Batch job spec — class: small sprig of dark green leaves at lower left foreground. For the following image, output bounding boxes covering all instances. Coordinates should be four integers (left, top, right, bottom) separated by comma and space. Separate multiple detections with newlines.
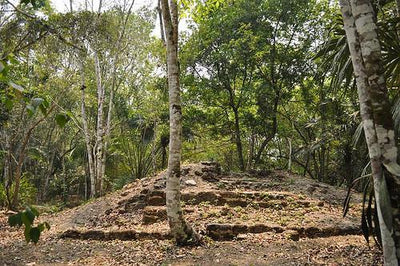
8, 206, 50, 244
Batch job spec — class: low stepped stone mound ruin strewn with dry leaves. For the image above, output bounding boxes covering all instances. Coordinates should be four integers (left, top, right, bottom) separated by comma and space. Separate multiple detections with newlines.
50, 162, 361, 240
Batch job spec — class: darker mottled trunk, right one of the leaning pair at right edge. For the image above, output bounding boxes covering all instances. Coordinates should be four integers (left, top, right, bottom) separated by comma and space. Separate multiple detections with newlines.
351, 0, 400, 262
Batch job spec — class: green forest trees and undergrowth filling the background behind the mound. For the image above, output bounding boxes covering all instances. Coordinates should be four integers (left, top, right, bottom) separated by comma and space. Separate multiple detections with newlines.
0, 0, 400, 241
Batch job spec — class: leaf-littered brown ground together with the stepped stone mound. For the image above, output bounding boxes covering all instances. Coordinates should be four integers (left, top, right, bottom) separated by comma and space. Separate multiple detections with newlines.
0, 163, 382, 266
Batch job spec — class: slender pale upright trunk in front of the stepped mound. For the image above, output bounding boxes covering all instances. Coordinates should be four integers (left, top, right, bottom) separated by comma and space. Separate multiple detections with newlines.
161, 0, 199, 245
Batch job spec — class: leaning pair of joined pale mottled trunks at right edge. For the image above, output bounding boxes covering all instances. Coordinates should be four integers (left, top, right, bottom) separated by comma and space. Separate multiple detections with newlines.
340, 0, 400, 265
